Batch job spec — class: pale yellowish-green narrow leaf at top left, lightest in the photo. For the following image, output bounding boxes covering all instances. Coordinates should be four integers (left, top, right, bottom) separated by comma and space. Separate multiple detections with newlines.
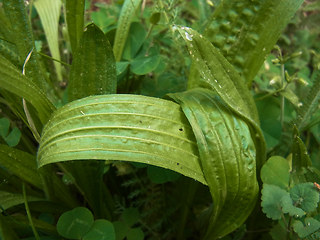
34, 0, 62, 81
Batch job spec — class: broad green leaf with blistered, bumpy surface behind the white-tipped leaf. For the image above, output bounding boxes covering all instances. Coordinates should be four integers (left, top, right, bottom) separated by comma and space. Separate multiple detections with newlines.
205, 0, 303, 85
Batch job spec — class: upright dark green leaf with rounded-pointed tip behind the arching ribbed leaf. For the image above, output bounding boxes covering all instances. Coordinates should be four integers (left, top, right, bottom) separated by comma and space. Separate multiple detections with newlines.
69, 23, 117, 101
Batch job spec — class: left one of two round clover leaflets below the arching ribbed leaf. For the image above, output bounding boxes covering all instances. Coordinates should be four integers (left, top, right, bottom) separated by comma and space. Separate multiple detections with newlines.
57, 207, 94, 239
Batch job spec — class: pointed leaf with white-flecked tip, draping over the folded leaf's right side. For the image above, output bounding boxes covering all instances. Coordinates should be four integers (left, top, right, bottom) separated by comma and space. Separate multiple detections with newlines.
176, 27, 266, 169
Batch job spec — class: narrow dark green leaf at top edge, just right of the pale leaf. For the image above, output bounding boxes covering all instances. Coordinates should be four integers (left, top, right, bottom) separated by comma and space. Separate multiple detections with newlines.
66, 0, 85, 53
